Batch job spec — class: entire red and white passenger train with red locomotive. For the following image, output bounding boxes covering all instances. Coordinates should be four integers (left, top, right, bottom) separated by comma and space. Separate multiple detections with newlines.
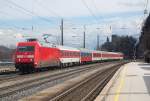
15, 39, 124, 73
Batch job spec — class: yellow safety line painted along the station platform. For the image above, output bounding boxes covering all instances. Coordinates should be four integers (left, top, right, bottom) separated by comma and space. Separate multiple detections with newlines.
114, 66, 127, 101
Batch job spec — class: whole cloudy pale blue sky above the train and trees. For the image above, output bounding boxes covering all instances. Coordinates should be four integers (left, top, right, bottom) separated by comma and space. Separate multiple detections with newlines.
0, 0, 150, 49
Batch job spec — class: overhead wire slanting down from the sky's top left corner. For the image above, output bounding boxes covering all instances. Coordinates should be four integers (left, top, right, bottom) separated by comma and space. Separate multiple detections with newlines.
6, 0, 52, 22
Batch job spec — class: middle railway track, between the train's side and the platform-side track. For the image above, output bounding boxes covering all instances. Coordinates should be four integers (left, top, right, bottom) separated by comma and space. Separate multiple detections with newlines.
0, 63, 116, 100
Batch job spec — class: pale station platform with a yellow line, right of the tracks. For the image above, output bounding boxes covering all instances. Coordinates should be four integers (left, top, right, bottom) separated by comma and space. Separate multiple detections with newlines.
95, 62, 150, 101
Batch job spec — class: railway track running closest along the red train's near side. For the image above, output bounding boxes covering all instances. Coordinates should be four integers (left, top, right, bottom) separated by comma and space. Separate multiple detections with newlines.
0, 62, 117, 84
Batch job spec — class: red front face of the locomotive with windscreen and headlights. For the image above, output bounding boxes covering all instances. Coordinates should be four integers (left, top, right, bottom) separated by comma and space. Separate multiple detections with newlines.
15, 42, 37, 73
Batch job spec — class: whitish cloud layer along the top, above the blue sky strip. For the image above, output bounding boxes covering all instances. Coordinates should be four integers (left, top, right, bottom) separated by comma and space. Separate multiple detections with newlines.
0, 0, 146, 19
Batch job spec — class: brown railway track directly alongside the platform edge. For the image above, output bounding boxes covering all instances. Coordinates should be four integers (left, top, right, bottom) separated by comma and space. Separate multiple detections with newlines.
50, 64, 125, 101
